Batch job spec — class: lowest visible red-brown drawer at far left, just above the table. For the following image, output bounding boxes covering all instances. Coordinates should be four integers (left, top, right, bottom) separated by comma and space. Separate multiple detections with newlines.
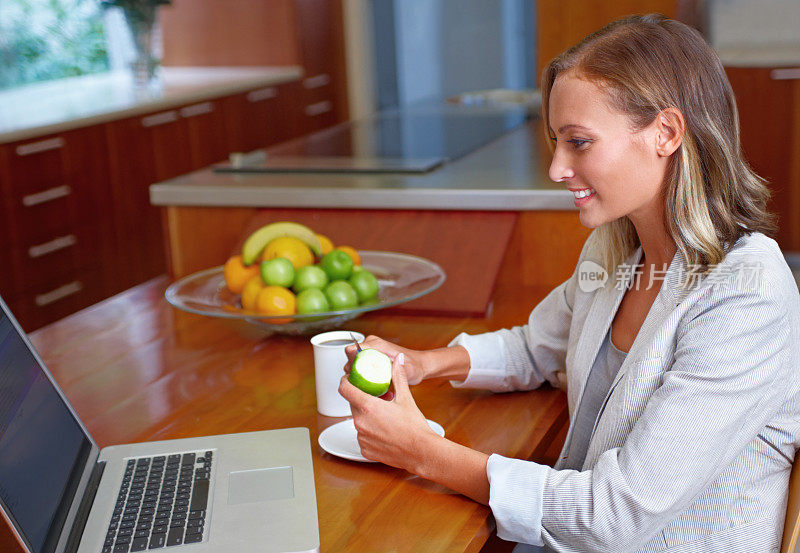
8, 268, 103, 332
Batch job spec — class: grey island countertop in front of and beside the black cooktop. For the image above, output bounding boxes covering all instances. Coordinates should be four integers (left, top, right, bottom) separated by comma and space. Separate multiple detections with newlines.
150, 120, 576, 211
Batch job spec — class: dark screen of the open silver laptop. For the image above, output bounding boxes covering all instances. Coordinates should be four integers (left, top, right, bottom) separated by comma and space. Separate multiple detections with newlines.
0, 309, 91, 553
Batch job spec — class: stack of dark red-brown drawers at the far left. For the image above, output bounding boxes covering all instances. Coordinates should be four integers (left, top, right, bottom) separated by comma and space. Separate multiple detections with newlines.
0, 127, 115, 330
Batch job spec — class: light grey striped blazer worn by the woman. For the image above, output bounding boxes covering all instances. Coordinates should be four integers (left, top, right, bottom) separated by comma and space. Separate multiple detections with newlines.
453, 229, 800, 553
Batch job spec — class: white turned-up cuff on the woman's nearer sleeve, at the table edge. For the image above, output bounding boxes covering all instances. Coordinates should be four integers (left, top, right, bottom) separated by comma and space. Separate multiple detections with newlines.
486, 454, 549, 545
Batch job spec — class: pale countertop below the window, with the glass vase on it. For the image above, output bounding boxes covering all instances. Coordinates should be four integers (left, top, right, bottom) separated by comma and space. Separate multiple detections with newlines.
0, 66, 303, 144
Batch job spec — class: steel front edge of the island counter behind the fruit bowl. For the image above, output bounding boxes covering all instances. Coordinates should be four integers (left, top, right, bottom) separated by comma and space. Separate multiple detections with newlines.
150, 184, 577, 211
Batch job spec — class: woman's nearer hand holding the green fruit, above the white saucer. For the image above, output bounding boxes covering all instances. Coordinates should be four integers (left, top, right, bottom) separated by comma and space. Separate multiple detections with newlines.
339, 353, 438, 473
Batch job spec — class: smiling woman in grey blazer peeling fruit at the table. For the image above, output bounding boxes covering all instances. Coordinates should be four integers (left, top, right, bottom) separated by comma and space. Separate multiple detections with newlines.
340, 15, 800, 553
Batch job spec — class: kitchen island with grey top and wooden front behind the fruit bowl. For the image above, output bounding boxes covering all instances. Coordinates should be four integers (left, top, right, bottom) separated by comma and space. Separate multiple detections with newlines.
150, 115, 589, 308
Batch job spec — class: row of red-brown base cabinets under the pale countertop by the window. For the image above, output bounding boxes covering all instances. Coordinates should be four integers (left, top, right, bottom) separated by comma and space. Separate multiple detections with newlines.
0, 81, 301, 331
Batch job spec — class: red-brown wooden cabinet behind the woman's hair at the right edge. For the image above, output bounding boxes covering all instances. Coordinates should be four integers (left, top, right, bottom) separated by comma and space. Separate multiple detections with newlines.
725, 67, 800, 252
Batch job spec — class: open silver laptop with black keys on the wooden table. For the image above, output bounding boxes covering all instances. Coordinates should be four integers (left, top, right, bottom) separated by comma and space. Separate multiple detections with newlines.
0, 298, 319, 553
